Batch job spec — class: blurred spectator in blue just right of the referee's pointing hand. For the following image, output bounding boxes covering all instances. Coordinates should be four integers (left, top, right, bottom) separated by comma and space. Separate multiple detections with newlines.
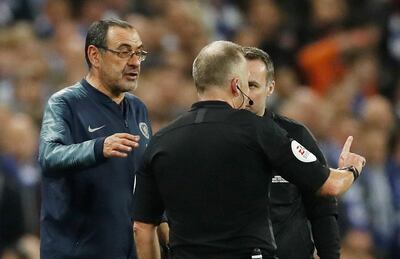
343, 129, 396, 258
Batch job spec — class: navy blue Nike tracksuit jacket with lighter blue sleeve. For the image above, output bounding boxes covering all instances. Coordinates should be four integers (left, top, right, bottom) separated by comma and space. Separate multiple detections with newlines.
39, 80, 151, 259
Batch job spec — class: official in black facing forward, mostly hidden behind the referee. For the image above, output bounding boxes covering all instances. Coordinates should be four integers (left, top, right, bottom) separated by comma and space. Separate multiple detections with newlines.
244, 47, 340, 259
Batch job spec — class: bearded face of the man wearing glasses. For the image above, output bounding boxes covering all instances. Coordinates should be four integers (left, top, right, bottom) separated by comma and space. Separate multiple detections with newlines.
99, 26, 143, 94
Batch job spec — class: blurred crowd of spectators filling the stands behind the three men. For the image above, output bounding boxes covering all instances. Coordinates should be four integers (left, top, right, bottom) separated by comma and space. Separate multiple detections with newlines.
0, 0, 400, 259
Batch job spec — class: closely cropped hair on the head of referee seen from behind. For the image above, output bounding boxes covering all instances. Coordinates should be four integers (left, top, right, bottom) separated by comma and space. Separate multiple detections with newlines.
192, 41, 247, 93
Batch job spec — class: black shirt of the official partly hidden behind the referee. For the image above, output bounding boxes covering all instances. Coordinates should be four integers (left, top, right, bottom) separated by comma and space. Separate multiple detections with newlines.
264, 111, 340, 259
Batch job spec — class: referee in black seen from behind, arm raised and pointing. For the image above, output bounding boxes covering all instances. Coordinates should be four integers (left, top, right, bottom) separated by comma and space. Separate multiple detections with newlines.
134, 41, 365, 259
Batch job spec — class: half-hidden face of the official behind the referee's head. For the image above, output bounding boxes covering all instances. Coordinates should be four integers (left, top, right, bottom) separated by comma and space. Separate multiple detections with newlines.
246, 59, 268, 116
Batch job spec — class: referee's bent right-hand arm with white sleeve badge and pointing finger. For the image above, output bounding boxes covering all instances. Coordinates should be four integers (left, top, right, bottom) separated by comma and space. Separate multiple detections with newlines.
256, 118, 365, 196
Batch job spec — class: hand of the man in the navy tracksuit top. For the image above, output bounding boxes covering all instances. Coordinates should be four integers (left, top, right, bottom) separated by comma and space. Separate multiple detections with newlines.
103, 133, 140, 157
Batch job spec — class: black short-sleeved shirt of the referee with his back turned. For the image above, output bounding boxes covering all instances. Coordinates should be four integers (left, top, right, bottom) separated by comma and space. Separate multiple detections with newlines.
134, 101, 329, 259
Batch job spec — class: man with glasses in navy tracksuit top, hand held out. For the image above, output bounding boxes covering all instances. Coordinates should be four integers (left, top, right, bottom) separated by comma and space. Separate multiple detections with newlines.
39, 20, 151, 259
